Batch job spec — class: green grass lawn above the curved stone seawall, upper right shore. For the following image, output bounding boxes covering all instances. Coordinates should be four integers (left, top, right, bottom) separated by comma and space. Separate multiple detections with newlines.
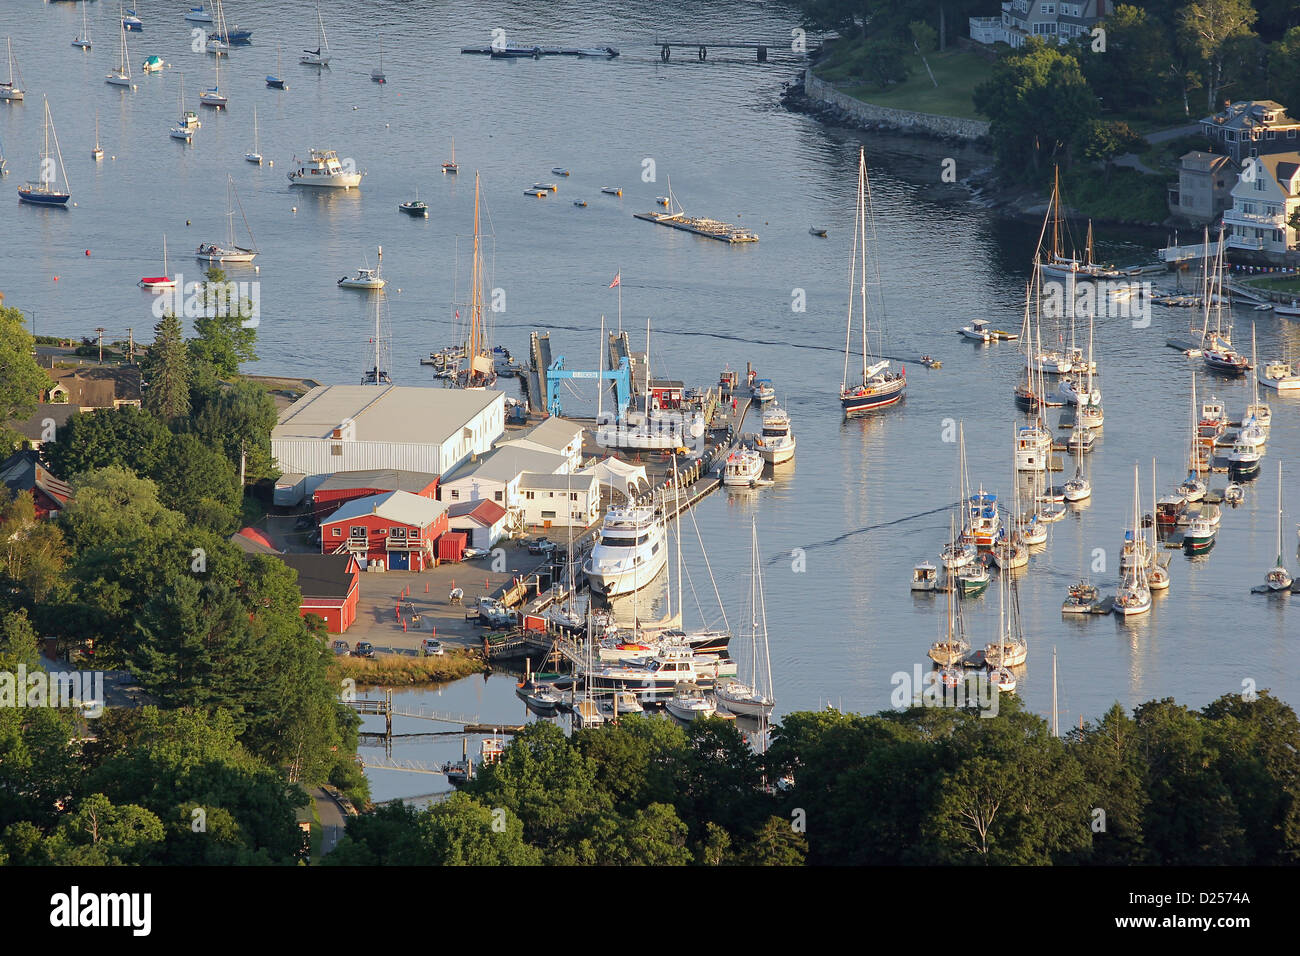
816, 47, 993, 120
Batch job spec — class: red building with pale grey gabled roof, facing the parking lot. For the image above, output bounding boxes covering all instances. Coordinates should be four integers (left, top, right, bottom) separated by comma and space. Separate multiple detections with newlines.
321, 492, 447, 571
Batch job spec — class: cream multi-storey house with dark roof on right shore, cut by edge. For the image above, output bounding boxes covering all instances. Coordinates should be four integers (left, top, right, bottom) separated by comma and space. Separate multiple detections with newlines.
1223, 152, 1300, 261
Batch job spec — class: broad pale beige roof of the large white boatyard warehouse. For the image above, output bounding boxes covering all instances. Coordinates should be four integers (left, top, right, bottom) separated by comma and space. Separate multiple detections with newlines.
270, 385, 504, 445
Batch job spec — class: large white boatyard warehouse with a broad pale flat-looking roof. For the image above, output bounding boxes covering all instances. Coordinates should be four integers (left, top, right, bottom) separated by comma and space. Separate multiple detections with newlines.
270, 385, 506, 505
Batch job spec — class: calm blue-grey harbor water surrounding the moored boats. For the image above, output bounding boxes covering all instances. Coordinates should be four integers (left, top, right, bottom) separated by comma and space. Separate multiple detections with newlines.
0, 0, 1300, 797
